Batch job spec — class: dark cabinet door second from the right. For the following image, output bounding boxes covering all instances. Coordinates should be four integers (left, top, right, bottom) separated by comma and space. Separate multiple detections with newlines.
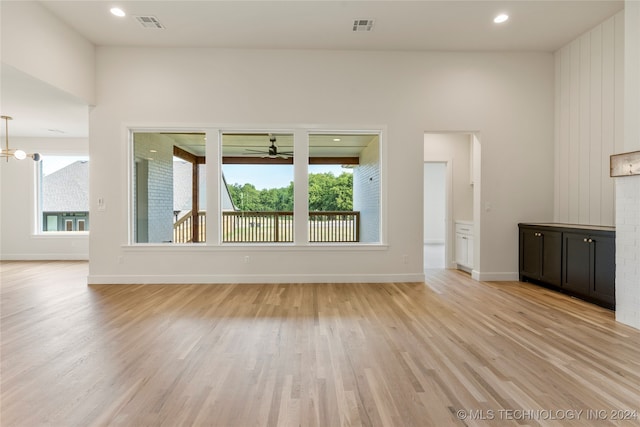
562, 233, 591, 296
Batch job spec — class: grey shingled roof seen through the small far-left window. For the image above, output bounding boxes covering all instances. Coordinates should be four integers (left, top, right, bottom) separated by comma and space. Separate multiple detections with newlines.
42, 160, 89, 212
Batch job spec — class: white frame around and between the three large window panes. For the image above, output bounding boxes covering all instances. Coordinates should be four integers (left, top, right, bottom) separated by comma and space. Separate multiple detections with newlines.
123, 124, 388, 247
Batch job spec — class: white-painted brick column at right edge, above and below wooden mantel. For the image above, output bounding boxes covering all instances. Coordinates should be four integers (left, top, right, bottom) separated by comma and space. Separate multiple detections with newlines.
615, 1, 640, 329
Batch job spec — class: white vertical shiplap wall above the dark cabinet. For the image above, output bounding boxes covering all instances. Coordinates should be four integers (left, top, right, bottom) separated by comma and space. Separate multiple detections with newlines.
554, 11, 624, 225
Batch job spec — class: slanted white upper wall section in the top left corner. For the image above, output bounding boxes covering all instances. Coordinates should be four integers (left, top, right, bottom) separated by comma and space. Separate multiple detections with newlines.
0, 1, 95, 104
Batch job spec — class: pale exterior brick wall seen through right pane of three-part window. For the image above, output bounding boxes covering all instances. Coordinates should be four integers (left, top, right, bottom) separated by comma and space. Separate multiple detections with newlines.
353, 136, 380, 243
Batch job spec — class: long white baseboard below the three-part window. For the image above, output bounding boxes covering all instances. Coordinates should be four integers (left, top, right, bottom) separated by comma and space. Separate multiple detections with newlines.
87, 273, 424, 285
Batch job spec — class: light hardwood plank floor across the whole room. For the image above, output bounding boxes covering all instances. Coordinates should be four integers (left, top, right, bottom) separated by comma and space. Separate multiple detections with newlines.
0, 262, 640, 427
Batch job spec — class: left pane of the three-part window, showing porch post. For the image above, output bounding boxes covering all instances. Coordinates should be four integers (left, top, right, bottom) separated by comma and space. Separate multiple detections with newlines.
133, 132, 206, 243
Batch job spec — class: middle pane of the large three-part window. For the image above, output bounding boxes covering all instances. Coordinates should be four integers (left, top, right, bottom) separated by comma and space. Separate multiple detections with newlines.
221, 132, 294, 243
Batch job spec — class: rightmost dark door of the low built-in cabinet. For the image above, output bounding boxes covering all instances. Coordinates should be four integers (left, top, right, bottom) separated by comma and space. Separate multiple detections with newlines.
589, 236, 616, 306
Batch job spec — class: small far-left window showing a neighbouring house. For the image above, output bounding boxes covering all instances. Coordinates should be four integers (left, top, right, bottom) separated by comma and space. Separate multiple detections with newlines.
38, 155, 89, 233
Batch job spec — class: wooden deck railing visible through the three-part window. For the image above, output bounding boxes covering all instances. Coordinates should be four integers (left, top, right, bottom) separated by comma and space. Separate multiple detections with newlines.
173, 211, 360, 243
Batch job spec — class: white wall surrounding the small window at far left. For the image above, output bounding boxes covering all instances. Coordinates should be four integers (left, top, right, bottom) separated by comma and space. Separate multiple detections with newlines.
0, 138, 91, 260
